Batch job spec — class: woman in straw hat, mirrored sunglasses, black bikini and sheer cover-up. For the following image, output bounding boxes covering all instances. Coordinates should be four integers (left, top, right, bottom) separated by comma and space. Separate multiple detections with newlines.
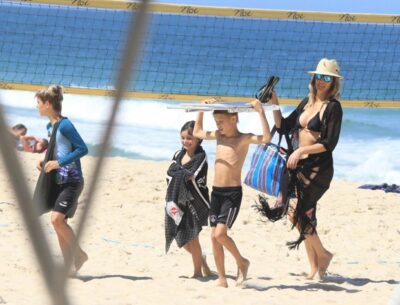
271, 58, 343, 279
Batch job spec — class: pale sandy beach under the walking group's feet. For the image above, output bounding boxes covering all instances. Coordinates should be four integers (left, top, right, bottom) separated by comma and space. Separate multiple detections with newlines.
0, 153, 400, 305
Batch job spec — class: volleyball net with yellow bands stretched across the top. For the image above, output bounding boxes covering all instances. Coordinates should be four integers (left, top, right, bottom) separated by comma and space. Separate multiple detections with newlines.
0, 0, 400, 107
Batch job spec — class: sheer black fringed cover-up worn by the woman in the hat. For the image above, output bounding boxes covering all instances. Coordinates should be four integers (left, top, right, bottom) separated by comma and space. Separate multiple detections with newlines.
270, 98, 343, 249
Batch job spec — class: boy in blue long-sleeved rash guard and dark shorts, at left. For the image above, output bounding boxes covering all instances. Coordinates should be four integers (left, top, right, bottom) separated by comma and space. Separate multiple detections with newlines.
36, 85, 88, 271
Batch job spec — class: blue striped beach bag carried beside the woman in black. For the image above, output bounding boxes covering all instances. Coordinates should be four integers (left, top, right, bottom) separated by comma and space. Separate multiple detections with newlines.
244, 128, 290, 197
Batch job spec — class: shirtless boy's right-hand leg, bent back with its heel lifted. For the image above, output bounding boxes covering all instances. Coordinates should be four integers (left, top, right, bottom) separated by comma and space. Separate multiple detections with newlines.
214, 223, 250, 284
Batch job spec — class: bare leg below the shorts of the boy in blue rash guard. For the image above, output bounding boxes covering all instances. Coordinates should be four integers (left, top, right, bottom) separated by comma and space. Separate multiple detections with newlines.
51, 211, 88, 271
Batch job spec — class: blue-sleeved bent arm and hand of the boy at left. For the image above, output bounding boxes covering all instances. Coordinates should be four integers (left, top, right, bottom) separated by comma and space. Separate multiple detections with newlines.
44, 119, 88, 173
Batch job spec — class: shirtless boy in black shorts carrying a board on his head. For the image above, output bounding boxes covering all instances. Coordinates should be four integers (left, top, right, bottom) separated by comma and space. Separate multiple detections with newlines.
193, 100, 271, 287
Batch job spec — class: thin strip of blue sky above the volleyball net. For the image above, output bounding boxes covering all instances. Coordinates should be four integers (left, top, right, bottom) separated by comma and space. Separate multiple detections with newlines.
155, 0, 400, 15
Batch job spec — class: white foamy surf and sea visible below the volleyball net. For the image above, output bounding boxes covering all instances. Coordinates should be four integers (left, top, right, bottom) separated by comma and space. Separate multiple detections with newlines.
0, 90, 400, 184
